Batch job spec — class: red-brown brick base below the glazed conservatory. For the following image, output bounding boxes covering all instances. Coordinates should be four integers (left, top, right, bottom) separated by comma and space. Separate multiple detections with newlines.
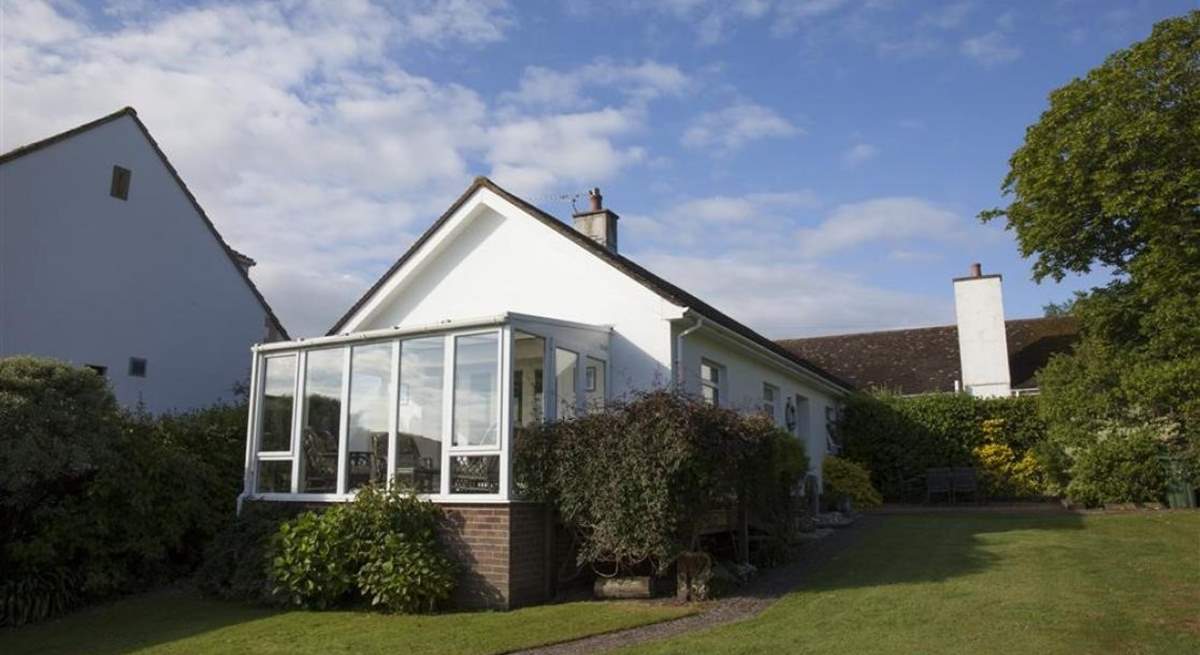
442, 503, 548, 609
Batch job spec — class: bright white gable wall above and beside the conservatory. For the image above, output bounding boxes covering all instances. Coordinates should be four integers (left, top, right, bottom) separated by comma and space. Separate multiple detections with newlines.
347, 190, 682, 396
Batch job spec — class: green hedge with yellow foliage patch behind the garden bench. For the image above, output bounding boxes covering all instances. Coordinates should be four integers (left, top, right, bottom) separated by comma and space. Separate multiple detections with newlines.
838, 393, 1050, 501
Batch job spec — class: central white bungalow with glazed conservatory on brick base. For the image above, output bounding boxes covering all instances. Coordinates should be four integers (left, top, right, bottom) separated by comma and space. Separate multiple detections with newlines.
242, 178, 850, 607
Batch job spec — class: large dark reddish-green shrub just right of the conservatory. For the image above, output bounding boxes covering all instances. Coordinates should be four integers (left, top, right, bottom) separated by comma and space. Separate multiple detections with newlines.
515, 391, 806, 573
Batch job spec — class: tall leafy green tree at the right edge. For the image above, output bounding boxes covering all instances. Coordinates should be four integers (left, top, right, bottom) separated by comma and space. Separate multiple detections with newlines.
980, 12, 1200, 493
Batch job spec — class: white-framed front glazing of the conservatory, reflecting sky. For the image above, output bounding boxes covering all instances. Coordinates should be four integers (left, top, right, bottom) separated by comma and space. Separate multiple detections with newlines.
254, 330, 506, 495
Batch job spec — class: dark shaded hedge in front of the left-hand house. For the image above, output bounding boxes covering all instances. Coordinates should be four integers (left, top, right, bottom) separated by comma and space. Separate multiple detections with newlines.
0, 356, 246, 625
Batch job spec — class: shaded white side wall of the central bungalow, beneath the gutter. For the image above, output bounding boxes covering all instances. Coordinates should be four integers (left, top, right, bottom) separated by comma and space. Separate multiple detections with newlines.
682, 330, 836, 487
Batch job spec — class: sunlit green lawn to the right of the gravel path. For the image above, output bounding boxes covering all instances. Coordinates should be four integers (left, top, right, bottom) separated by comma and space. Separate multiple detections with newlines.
623, 512, 1200, 655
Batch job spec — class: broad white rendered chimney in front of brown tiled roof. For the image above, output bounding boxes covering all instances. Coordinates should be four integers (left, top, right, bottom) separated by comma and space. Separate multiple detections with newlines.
954, 264, 1013, 397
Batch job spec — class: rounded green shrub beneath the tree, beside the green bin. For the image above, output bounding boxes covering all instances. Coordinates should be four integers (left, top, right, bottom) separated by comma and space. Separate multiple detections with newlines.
1067, 423, 1166, 507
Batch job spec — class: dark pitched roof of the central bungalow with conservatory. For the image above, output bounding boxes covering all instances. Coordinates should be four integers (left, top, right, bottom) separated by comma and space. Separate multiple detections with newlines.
328, 176, 851, 389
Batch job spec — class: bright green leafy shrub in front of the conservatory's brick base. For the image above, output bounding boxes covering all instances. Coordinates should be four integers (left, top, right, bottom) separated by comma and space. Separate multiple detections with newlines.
269, 487, 454, 612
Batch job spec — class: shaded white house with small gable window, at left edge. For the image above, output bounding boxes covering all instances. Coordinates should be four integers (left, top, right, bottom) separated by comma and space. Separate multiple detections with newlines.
0, 108, 287, 413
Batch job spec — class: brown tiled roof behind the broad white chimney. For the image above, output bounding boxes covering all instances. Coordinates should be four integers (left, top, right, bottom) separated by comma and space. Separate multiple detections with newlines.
779, 317, 1079, 393
